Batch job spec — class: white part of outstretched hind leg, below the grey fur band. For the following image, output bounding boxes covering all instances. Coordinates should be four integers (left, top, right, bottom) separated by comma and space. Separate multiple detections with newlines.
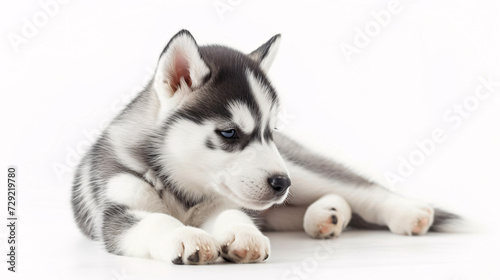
290, 166, 434, 235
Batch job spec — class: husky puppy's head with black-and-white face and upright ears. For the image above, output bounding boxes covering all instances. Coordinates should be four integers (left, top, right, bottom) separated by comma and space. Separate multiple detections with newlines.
152, 30, 291, 210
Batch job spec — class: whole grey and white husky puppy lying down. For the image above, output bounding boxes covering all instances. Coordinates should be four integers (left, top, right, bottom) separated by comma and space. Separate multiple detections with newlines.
72, 30, 457, 264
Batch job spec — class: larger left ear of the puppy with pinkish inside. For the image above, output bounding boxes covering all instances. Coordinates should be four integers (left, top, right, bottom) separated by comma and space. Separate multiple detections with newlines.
154, 30, 210, 97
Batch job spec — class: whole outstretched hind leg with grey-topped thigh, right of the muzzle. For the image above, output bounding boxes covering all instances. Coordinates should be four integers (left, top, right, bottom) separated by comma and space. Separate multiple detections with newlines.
275, 134, 456, 235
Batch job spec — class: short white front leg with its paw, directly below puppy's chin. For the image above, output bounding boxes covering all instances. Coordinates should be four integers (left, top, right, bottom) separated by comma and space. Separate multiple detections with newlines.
202, 210, 271, 263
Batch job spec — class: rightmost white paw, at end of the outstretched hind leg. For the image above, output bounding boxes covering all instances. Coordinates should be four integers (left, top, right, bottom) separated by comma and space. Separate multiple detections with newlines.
387, 201, 434, 235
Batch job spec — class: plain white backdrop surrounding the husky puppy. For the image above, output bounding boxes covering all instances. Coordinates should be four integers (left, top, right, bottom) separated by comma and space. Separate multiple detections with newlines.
0, 0, 500, 280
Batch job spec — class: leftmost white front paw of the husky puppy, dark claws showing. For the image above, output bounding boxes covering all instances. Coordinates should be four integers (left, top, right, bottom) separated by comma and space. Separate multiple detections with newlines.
171, 227, 220, 264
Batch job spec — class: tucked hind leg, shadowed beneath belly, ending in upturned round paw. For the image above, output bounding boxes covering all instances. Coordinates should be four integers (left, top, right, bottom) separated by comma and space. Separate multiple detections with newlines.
262, 194, 351, 238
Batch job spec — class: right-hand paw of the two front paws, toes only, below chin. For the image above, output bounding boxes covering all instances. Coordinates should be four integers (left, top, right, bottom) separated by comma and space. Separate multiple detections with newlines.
217, 225, 271, 263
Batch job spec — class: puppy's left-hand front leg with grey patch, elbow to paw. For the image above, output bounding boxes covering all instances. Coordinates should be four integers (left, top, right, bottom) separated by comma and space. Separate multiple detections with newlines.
101, 174, 219, 264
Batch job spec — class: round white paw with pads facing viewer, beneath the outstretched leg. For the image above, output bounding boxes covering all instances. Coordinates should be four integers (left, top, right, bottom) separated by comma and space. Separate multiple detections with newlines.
304, 204, 347, 239
